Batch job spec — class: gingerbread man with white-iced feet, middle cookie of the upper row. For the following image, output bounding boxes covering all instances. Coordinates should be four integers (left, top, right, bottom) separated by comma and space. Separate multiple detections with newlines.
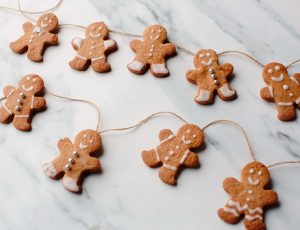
127, 25, 176, 77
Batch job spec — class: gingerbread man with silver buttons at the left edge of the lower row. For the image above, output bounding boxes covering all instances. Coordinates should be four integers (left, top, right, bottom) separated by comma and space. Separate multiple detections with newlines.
0, 74, 46, 131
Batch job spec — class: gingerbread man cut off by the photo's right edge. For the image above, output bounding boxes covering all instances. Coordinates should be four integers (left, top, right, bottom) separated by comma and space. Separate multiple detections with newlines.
260, 62, 300, 121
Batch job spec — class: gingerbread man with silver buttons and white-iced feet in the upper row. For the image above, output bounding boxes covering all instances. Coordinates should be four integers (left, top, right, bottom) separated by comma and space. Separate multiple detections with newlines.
186, 49, 236, 104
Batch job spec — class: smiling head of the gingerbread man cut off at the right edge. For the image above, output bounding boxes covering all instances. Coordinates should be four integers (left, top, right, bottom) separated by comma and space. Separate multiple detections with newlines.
262, 62, 288, 84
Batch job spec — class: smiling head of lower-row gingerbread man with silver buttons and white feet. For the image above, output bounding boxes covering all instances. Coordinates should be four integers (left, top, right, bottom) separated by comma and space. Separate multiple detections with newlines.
74, 129, 101, 154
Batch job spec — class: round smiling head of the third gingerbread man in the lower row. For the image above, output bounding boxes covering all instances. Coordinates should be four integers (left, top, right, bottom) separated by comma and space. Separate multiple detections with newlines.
177, 124, 204, 148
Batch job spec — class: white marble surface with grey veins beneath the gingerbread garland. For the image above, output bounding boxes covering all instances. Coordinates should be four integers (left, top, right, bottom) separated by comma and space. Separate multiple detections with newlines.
0, 0, 300, 230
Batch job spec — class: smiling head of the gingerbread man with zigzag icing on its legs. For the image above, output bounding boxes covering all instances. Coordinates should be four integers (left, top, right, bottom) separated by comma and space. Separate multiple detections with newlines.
241, 161, 270, 188
